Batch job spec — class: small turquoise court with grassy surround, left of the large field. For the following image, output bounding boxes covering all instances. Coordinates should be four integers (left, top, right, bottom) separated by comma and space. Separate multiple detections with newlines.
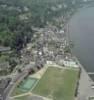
11, 78, 37, 96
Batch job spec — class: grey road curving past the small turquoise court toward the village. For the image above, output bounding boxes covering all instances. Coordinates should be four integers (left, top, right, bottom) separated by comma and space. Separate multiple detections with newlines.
3, 64, 33, 100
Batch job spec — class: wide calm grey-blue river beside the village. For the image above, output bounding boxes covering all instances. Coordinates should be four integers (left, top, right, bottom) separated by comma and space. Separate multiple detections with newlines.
69, 7, 94, 79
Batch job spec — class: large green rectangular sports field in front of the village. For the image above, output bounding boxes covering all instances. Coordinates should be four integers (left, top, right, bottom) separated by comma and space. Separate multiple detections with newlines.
32, 67, 78, 100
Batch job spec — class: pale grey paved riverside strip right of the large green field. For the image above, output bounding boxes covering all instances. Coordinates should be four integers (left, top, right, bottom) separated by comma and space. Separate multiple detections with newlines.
76, 58, 94, 100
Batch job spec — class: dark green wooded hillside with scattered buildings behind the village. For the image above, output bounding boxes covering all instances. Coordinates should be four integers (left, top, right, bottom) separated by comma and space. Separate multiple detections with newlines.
0, 0, 83, 51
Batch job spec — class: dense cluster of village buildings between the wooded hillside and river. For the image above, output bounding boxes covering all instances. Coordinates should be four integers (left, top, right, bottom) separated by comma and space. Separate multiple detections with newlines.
1, 23, 80, 99
